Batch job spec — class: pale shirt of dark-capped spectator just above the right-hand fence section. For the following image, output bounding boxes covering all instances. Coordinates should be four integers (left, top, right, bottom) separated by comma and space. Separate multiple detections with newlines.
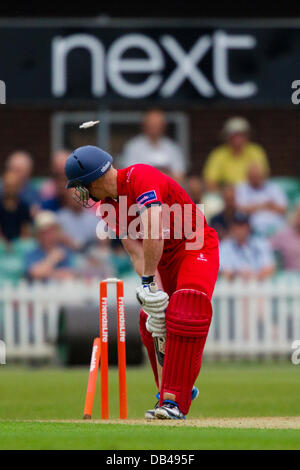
220, 236, 274, 273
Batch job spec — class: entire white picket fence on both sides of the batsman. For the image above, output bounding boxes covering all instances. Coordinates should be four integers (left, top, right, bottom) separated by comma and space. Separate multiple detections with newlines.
0, 278, 300, 360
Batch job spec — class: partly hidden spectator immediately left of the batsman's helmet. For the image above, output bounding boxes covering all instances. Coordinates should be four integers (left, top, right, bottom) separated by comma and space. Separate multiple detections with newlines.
40, 149, 71, 212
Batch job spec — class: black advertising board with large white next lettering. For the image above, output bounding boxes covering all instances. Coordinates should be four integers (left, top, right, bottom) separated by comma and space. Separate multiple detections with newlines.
0, 20, 300, 106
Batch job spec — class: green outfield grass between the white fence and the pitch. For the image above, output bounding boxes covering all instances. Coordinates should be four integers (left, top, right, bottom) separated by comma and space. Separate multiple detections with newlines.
0, 363, 300, 420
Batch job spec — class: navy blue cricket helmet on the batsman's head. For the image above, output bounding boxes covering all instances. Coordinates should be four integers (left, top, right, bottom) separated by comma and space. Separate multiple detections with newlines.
65, 145, 113, 189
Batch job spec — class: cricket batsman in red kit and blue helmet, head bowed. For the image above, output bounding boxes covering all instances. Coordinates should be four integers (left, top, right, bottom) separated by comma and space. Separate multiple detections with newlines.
65, 145, 219, 419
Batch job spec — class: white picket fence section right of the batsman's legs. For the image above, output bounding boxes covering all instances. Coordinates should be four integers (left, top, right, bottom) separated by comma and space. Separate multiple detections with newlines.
205, 277, 300, 356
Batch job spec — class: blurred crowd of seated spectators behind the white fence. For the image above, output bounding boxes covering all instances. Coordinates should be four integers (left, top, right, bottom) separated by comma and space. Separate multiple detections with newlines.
0, 109, 300, 283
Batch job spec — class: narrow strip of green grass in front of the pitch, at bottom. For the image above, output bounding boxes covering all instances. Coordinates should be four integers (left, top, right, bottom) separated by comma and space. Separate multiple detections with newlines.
0, 422, 300, 450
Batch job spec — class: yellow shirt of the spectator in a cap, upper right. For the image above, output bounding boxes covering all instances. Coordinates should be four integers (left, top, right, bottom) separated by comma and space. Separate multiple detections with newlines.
203, 142, 269, 186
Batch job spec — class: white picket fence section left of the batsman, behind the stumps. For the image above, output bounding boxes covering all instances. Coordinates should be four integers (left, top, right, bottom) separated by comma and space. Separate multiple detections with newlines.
0, 277, 137, 360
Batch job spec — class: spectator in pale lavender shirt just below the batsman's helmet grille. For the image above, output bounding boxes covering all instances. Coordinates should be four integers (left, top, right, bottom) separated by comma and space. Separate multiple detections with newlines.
57, 191, 99, 249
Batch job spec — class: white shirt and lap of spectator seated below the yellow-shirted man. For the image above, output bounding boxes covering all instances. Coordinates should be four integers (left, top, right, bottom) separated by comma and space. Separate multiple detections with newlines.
236, 182, 287, 236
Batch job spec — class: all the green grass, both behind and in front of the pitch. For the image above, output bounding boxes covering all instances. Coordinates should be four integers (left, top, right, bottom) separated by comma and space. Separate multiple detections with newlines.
0, 363, 300, 449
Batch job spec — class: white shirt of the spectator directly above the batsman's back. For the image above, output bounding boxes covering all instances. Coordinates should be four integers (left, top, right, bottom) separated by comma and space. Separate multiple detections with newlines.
122, 135, 186, 173
